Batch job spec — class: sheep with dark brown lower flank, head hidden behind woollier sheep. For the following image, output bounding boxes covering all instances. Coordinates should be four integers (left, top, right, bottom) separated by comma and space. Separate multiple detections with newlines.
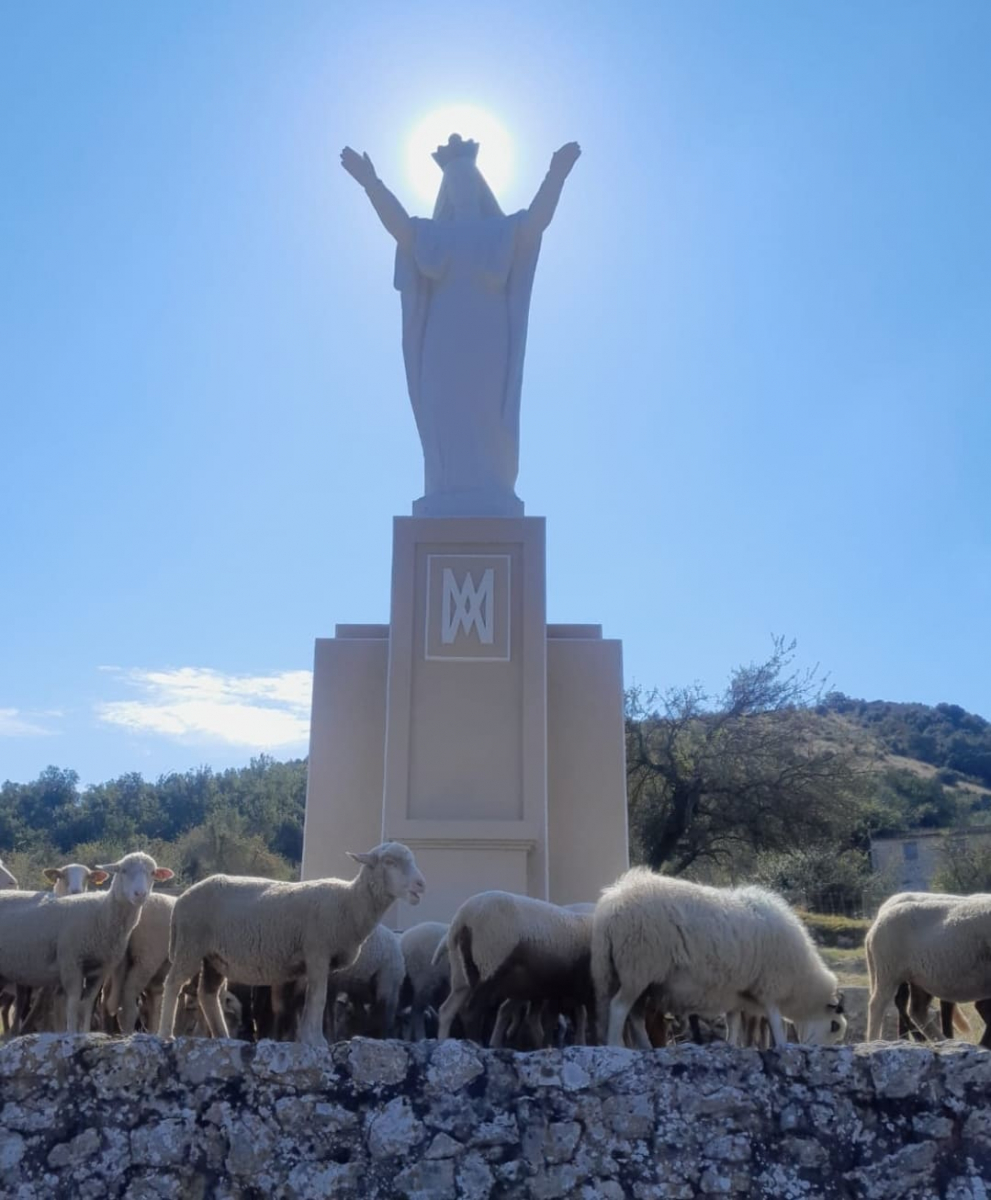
433, 892, 593, 1046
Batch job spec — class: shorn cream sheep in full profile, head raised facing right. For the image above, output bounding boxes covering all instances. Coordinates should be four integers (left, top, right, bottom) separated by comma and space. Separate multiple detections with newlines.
158, 841, 426, 1045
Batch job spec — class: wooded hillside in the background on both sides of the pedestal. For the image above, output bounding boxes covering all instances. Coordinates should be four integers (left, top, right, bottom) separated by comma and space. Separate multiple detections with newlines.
0, 692, 991, 887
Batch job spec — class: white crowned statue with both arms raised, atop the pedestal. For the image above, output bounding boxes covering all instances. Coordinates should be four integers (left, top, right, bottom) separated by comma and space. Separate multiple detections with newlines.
341, 133, 582, 516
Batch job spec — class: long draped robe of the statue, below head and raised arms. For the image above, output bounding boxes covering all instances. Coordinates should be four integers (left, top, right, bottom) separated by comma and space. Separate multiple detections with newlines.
395, 212, 540, 515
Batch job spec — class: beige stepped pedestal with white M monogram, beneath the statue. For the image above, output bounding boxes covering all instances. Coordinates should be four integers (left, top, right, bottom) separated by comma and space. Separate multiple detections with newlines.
302, 517, 627, 928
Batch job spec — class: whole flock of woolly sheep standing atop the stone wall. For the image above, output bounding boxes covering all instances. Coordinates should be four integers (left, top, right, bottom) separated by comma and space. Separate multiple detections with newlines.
0, 842, 991, 1049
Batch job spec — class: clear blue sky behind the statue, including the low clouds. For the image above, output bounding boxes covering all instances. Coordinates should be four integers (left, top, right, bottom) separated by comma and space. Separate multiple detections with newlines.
0, 0, 991, 781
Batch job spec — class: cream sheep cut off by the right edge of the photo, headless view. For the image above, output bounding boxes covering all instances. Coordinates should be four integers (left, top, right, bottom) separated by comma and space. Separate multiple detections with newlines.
864, 892, 991, 1048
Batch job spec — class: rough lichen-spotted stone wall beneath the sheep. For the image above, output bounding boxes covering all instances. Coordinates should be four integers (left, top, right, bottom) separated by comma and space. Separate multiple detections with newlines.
0, 1034, 991, 1200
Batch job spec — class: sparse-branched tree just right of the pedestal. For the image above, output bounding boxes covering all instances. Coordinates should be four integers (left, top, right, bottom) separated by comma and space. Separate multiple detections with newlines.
626, 638, 870, 874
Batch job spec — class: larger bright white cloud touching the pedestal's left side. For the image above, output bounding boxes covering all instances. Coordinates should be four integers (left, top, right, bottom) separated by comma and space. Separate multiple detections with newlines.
96, 667, 312, 750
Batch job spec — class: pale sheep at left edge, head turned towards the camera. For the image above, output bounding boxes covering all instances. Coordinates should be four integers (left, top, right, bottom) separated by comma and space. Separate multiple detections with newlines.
0, 852, 173, 1033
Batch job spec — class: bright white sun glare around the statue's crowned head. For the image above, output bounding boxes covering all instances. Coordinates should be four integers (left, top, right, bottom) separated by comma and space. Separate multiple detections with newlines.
406, 104, 512, 206
